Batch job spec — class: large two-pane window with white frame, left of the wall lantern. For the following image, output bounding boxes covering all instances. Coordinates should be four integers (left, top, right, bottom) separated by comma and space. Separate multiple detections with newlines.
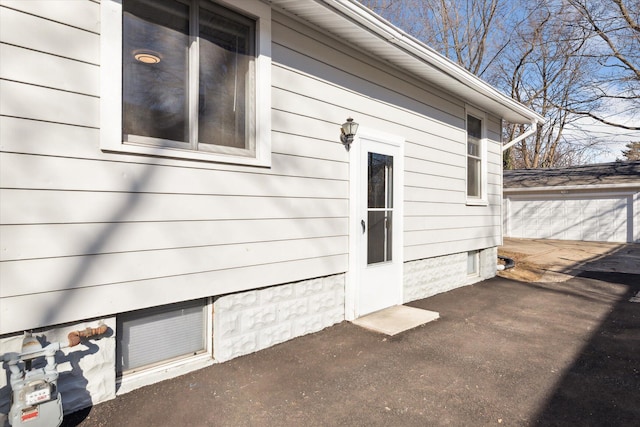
102, 0, 270, 165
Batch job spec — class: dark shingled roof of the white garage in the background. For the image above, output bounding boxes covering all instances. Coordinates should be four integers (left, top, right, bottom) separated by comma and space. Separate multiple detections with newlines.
503, 161, 640, 188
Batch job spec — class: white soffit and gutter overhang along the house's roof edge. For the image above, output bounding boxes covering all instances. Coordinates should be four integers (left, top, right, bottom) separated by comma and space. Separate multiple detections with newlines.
270, 0, 544, 123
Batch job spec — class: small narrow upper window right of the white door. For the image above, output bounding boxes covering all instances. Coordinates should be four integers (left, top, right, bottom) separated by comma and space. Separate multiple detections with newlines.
467, 107, 486, 201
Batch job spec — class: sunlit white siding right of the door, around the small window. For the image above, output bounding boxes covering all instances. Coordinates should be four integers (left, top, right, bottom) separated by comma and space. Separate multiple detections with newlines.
404, 113, 502, 260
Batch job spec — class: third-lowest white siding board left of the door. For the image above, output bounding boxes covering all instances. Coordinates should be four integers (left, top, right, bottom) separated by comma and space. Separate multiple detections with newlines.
2, 218, 347, 261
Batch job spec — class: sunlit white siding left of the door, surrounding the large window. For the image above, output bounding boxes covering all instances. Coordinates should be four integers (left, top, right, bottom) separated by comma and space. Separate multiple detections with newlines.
0, 1, 349, 333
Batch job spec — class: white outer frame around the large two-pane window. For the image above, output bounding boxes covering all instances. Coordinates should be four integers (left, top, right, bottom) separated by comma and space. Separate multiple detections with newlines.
100, 0, 271, 167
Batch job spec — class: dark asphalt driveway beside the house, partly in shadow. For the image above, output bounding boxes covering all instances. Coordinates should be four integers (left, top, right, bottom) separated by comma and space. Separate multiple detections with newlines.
64, 245, 640, 427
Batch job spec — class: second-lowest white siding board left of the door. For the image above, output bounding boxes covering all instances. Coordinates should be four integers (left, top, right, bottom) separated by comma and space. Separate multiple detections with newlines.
0, 236, 347, 298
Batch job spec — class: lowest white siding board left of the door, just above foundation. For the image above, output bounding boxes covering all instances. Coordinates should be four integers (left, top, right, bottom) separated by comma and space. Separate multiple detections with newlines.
0, 255, 347, 333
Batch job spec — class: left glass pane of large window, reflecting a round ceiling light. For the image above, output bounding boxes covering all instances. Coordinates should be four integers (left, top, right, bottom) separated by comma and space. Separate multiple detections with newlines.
122, 0, 189, 142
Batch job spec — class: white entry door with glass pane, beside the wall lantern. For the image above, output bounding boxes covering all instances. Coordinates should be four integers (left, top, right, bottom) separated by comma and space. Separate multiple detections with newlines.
351, 131, 404, 317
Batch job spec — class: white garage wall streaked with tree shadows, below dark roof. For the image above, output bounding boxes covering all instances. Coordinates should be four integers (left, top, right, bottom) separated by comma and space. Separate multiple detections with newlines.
505, 196, 633, 242
